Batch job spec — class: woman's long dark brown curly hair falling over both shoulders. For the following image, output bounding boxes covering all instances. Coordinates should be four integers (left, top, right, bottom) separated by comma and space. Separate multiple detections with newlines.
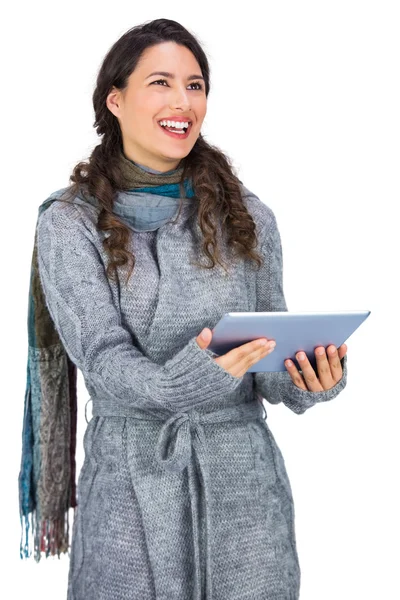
55, 19, 263, 281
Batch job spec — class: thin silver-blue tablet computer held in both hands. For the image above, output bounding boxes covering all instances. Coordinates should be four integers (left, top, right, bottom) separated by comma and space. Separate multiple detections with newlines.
208, 310, 371, 373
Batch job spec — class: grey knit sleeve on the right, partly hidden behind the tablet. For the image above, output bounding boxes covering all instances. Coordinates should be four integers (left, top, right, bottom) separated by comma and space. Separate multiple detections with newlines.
253, 209, 347, 414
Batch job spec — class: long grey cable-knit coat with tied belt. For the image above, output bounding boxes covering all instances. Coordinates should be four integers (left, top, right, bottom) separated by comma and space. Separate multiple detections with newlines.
30, 170, 346, 600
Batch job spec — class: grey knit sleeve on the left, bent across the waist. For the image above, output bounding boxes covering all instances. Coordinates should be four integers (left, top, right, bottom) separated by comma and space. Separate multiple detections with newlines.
37, 202, 242, 411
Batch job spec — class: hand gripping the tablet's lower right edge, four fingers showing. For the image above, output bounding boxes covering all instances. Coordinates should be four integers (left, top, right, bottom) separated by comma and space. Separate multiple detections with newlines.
285, 344, 347, 392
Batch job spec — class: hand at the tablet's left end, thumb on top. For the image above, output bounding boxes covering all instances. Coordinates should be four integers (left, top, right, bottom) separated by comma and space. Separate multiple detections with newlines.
196, 327, 275, 377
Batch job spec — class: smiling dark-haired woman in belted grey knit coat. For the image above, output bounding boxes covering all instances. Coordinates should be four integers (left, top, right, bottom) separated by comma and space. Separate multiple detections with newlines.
30, 19, 347, 600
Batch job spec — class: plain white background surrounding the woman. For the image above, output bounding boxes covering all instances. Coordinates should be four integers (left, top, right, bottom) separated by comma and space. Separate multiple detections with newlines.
0, 0, 400, 600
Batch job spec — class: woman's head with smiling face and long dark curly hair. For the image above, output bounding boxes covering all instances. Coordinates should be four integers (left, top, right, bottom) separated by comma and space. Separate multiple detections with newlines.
50, 19, 268, 288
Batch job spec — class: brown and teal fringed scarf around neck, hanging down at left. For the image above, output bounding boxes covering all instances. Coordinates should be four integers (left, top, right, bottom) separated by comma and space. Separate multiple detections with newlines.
18, 151, 194, 562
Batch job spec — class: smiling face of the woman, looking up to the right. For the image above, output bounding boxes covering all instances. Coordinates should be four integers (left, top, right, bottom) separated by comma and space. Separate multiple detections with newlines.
107, 42, 207, 171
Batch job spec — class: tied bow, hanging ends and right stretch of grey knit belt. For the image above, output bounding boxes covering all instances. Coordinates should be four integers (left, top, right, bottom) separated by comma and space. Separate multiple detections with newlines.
156, 400, 263, 600
